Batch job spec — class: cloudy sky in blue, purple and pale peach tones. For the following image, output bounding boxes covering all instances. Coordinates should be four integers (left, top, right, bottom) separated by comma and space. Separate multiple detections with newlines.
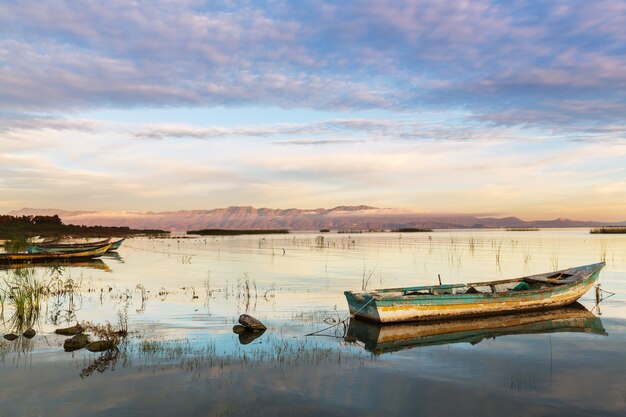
0, 0, 626, 221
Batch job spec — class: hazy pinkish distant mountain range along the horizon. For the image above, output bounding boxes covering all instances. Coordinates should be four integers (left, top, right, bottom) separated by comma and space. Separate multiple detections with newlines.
8, 206, 626, 231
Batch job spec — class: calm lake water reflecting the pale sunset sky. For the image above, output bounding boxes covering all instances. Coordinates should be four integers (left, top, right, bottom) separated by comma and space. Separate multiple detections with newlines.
0, 229, 626, 417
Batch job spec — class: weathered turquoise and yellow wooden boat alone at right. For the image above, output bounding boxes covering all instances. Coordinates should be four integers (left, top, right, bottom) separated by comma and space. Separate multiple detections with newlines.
344, 262, 605, 323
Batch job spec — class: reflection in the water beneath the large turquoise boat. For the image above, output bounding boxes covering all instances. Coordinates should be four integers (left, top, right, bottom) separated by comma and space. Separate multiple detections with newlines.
345, 303, 607, 355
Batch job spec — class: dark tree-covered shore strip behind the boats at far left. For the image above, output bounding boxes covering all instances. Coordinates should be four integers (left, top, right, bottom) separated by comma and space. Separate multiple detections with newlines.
0, 215, 170, 240
